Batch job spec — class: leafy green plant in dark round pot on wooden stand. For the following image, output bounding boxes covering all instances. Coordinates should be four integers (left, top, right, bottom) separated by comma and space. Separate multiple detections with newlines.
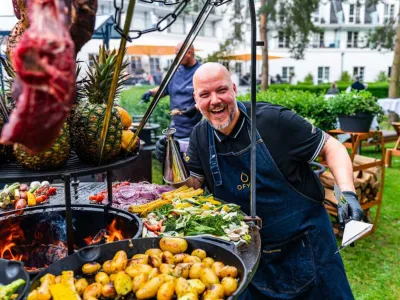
328, 91, 383, 132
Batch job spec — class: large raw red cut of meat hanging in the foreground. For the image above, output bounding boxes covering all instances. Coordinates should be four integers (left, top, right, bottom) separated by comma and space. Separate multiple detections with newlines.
0, 0, 75, 153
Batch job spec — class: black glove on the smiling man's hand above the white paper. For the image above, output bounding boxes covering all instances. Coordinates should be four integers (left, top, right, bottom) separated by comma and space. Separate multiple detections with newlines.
338, 192, 364, 225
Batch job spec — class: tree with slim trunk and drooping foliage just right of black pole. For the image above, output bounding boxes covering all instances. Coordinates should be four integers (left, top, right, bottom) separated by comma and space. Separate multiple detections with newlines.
259, 0, 320, 89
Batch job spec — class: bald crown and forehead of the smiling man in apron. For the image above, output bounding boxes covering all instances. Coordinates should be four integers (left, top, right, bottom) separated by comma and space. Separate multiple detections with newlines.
193, 62, 232, 91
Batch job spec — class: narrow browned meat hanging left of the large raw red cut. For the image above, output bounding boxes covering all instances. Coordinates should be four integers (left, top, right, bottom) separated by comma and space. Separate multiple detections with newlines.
6, 0, 29, 57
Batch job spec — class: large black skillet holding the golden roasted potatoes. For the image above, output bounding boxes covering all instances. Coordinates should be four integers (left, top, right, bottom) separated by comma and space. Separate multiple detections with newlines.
31, 237, 248, 299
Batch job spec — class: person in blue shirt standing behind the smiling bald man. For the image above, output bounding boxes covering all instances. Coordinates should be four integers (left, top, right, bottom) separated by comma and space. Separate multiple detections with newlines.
142, 43, 202, 139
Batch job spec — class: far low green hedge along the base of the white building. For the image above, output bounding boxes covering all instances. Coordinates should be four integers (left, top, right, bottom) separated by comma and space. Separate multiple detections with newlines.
269, 82, 389, 99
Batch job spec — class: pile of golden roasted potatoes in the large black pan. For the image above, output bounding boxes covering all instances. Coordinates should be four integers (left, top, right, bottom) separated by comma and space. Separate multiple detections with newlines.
29, 238, 238, 300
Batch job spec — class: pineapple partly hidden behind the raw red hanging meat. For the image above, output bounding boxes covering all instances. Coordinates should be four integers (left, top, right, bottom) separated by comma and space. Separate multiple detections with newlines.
14, 122, 71, 171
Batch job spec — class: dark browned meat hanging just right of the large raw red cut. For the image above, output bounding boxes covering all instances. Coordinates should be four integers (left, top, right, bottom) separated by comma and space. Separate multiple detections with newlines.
69, 0, 97, 53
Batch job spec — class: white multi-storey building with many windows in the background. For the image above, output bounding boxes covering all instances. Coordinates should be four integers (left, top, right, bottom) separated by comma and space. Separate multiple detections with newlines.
0, 0, 399, 84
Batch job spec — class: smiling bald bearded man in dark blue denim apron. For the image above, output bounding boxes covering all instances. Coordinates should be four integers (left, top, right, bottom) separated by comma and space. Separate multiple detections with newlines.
158, 63, 363, 299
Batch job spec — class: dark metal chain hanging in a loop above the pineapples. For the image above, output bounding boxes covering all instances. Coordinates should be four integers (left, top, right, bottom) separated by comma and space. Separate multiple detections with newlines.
113, 0, 231, 42
